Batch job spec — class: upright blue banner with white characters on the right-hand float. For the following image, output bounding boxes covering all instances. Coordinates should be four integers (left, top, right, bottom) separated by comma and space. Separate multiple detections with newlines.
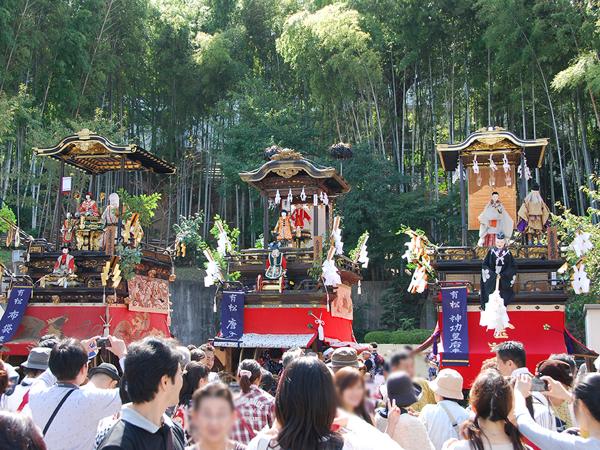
442, 286, 469, 366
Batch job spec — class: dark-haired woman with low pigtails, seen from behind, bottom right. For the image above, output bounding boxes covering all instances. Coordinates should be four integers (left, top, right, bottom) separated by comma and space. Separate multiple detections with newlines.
443, 369, 528, 450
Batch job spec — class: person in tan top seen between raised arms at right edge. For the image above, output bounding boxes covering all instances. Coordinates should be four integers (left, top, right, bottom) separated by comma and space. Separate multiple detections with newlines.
536, 359, 575, 431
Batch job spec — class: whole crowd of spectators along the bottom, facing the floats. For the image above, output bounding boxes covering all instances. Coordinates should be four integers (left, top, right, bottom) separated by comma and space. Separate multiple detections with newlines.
0, 336, 600, 450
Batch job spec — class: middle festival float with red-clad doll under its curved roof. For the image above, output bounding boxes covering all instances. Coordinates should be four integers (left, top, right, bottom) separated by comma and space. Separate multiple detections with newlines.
205, 144, 368, 370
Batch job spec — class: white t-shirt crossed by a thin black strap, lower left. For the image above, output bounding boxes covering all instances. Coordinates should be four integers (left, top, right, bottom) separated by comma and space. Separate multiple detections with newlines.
28, 383, 121, 450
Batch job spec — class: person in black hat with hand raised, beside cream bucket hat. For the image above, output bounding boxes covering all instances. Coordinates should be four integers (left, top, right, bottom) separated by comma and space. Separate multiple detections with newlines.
375, 372, 435, 450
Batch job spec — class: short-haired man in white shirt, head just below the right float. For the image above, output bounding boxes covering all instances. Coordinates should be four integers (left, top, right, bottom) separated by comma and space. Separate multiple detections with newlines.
494, 341, 556, 431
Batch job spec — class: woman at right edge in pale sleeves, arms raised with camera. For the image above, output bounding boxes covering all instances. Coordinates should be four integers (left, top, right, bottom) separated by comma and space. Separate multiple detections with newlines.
515, 373, 600, 450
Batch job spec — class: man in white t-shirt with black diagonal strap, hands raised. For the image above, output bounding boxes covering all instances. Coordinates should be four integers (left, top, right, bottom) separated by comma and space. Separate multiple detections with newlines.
29, 336, 127, 450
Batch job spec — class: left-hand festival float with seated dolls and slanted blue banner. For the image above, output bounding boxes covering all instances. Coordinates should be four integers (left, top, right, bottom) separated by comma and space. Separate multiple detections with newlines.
0, 130, 175, 356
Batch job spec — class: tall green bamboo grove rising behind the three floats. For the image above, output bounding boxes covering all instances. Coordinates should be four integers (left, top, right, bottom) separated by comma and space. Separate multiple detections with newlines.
0, 0, 600, 292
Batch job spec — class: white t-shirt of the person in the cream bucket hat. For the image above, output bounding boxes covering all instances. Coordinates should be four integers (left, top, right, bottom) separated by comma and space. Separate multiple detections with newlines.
419, 400, 469, 450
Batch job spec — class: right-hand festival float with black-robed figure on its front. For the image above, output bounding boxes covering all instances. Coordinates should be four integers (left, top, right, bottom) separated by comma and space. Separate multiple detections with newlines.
412, 127, 598, 386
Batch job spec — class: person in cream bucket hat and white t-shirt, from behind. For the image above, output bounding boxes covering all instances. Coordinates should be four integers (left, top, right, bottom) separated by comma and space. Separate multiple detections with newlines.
419, 369, 469, 450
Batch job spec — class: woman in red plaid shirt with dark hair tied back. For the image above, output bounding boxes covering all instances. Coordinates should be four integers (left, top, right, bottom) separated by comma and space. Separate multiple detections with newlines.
231, 359, 275, 444
